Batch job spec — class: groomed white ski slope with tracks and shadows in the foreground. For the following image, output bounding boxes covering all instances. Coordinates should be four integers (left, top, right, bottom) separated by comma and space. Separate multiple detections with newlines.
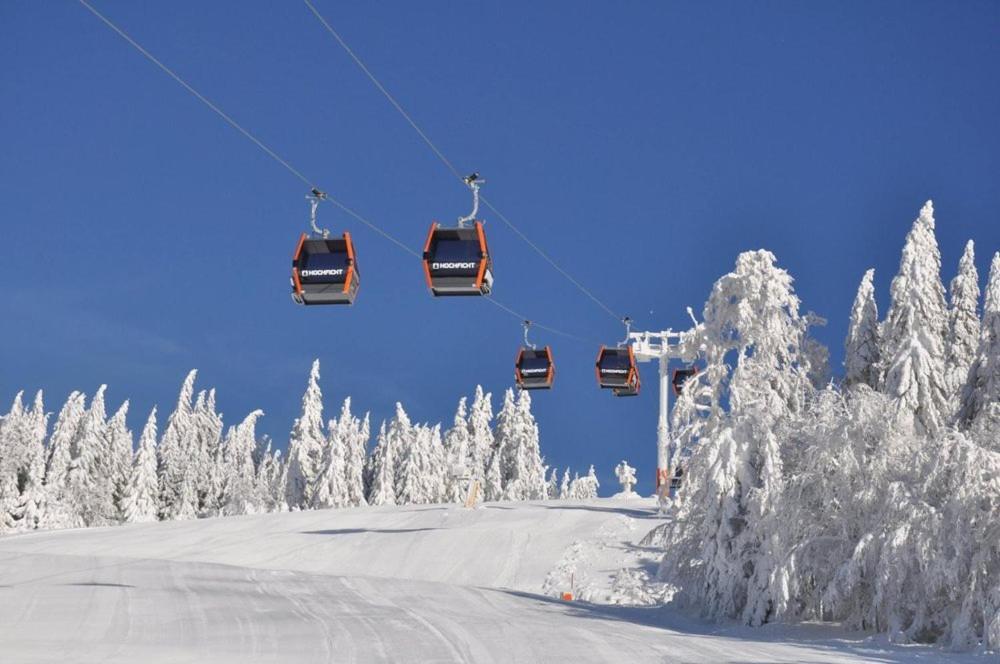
0, 499, 984, 664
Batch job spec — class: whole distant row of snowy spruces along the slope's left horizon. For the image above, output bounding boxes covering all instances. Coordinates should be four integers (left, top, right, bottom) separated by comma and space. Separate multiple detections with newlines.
0, 361, 598, 533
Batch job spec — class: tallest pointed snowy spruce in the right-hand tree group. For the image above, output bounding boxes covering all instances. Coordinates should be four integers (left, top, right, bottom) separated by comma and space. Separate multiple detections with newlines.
882, 201, 950, 434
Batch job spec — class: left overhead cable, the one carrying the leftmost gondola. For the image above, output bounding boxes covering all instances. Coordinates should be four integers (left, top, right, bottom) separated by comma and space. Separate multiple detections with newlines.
78, 0, 590, 343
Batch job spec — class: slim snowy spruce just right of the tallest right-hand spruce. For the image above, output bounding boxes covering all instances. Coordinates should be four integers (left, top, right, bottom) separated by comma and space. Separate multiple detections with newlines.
945, 240, 980, 404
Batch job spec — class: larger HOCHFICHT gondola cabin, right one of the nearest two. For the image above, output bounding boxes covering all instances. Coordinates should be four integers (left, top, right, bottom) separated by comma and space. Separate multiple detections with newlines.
423, 221, 493, 297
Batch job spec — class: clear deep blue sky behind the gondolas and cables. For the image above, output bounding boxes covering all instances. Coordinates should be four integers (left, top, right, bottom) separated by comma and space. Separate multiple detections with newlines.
0, 0, 1000, 491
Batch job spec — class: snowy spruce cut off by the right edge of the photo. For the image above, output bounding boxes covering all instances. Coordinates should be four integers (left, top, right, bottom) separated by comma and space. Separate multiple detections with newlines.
960, 252, 1000, 426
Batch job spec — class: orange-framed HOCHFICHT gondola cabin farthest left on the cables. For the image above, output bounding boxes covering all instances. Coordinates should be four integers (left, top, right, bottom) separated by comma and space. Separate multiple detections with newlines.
292, 233, 361, 305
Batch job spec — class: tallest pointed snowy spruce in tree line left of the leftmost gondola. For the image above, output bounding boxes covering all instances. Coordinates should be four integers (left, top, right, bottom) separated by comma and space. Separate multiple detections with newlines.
156, 370, 198, 519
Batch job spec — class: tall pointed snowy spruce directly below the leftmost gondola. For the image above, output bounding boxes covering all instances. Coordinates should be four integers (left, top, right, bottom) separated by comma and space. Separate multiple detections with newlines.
285, 360, 326, 510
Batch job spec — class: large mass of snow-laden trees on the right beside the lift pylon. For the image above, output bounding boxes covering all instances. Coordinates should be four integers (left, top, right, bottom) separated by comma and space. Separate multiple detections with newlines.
652, 202, 1000, 649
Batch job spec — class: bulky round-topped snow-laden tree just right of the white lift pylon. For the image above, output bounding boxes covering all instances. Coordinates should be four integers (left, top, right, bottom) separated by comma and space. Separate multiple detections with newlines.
660, 250, 813, 625
